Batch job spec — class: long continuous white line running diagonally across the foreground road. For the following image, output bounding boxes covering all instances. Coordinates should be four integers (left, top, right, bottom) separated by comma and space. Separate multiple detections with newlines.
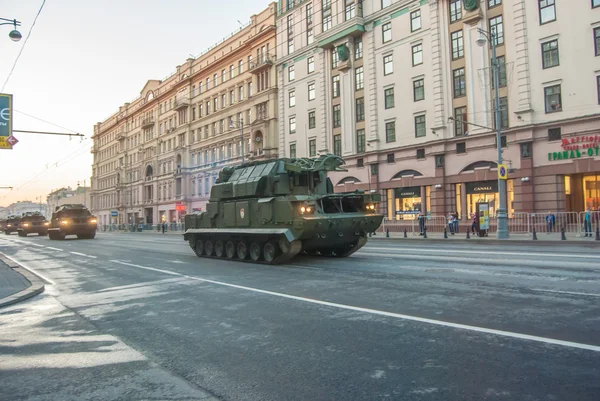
111, 260, 600, 352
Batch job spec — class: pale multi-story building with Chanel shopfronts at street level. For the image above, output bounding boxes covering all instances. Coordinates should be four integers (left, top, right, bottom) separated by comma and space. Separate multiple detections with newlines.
277, 0, 600, 218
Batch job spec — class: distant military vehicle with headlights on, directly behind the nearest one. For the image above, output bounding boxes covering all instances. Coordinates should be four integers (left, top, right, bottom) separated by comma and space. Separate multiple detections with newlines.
48, 204, 97, 240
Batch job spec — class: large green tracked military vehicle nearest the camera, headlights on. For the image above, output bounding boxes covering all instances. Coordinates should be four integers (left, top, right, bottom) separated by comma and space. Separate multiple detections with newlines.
183, 155, 383, 264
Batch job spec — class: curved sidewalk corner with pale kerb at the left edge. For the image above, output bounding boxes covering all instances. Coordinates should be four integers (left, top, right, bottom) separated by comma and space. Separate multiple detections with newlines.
0, 254, 44, 308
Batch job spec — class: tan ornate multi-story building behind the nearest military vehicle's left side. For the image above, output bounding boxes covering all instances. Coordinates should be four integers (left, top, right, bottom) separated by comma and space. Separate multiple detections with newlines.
92, 3, 278, 224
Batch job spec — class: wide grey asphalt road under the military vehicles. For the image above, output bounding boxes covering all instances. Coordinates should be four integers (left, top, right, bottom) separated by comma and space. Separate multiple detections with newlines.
0, 233, 600, 401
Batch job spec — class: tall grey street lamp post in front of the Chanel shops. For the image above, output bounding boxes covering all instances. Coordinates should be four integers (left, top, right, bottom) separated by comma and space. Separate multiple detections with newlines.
477, 28, 509, 239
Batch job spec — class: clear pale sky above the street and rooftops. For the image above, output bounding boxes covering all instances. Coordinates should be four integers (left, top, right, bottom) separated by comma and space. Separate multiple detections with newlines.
0, 0, 269, 206
